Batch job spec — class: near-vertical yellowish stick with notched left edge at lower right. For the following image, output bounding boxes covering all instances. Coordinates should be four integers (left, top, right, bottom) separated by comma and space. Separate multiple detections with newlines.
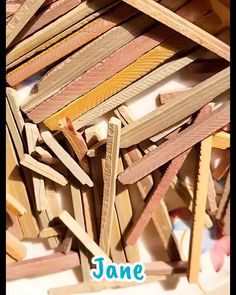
187, 136, 212, 284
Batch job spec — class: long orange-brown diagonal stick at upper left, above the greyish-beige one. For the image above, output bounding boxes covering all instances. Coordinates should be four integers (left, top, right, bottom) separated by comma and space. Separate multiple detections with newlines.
7, 3, 138, 86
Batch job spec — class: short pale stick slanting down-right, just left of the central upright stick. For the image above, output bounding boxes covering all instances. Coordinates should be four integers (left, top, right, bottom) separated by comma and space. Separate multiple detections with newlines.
41, 131, 93, 187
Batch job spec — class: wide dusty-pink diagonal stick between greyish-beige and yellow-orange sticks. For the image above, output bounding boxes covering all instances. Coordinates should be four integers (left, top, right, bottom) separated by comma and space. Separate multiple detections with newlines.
24, 0, 209, 121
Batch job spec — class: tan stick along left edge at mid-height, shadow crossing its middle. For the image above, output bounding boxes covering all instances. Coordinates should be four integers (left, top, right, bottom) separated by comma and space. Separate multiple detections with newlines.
6, 128, 39, 238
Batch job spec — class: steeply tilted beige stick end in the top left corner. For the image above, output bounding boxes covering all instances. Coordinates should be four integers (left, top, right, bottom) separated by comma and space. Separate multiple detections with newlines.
6, 0, 45, 47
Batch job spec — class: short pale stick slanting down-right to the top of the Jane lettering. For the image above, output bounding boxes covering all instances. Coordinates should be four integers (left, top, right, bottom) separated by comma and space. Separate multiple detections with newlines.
58, 210, 109, 259
